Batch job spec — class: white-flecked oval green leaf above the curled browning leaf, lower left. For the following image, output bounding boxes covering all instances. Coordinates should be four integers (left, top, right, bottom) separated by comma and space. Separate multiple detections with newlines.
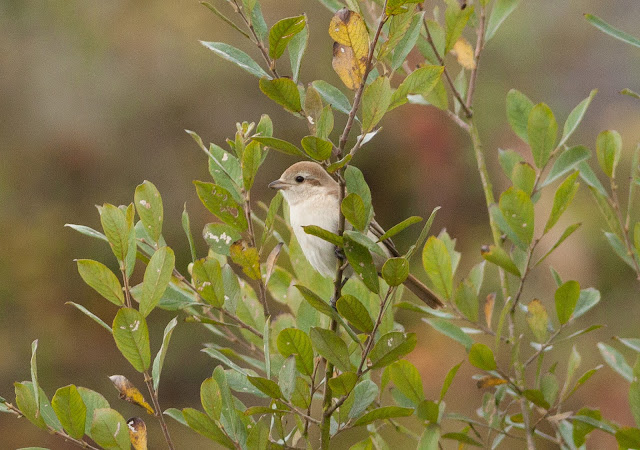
112, 308, 151, 372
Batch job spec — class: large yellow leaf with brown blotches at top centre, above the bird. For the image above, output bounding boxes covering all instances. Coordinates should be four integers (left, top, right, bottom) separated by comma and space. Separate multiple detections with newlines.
329, 8, 369, 89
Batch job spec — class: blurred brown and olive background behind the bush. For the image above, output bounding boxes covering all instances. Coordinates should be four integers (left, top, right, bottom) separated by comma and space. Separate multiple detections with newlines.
0, 0, 640, 449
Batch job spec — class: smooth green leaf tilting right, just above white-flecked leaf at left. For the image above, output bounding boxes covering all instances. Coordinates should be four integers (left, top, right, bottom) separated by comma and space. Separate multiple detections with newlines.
140, 247, 176, 317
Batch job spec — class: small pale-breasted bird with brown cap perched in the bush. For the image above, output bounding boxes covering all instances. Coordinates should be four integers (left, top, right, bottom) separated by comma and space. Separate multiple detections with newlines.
269, 161, 444, 309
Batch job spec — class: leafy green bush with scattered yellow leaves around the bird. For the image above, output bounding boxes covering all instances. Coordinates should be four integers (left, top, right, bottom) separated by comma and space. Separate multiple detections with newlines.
0, 0, 640, 449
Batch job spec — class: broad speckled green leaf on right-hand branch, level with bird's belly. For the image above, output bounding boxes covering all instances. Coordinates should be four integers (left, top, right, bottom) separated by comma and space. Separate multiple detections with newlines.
494, 187, 534, 251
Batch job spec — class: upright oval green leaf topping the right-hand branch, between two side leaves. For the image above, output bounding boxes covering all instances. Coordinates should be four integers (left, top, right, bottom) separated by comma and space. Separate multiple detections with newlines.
527, 103, 558, 169
